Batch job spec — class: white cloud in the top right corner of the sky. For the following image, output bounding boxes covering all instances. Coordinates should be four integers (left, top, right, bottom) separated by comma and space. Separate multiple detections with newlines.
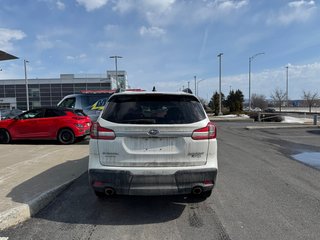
267, 0, 317, 25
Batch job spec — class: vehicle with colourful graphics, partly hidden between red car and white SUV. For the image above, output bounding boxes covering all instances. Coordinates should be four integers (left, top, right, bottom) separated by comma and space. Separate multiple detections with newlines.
58, 91, 113, 121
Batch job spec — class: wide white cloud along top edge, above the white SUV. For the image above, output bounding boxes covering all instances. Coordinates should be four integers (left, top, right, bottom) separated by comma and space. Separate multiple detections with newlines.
112, 0, 249, 28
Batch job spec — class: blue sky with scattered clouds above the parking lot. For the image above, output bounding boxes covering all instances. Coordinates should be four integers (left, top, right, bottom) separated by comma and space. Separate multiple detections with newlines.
0, 0, 320, 99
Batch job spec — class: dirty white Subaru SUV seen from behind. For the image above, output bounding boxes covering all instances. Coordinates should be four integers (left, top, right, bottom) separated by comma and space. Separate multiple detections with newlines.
88, 92, 218, 197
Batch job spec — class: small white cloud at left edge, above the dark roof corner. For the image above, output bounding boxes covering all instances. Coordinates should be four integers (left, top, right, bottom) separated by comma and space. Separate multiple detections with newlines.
0, 28, 26, 51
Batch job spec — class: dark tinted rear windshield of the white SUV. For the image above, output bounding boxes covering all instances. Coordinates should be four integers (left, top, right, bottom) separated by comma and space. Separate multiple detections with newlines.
102, 94, 206, 124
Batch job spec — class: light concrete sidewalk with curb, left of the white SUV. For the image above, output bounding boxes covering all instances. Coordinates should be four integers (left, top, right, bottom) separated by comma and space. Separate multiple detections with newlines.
0, 140, 89, 230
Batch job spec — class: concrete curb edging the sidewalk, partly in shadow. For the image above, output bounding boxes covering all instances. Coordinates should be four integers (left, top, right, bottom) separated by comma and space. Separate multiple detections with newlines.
0, 178, 76, 230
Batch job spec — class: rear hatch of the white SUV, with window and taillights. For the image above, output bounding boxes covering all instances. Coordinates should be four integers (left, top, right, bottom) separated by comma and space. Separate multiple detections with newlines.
91, 93, 215, 167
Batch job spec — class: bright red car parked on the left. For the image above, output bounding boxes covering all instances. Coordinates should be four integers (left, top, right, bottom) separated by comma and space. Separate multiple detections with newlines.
0, 107, 91, 144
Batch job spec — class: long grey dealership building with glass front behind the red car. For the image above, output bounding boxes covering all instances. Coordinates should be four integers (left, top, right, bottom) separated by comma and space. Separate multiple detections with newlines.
0, 71, 128, 110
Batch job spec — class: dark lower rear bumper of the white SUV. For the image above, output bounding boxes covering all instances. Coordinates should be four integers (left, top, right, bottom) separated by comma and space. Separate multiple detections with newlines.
89, 168, 217, 195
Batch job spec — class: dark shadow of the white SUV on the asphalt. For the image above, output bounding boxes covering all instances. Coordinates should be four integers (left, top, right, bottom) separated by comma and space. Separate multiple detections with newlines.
31, 173, 198, 225
